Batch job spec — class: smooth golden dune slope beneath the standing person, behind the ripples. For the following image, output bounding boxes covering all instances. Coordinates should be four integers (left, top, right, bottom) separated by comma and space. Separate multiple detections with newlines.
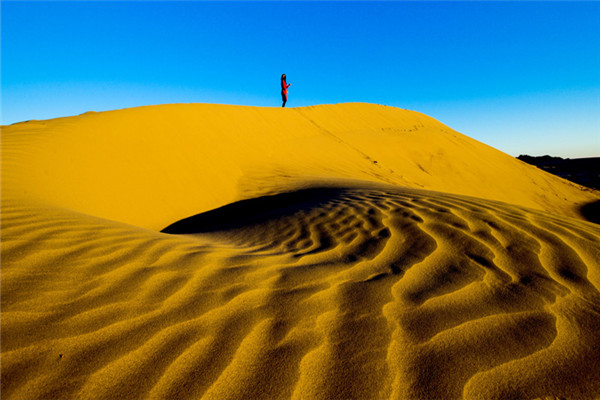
2, 103, 599, 230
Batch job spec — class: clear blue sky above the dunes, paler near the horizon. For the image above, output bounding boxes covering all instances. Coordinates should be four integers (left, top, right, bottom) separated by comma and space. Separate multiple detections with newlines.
0, 1, 600, 157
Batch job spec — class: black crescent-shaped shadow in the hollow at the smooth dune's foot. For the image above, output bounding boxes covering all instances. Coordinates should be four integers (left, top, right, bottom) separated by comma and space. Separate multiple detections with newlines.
161, 188, 345, 234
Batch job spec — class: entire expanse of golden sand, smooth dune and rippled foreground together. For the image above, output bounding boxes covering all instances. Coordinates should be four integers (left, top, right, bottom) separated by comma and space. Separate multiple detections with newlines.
1, 104, 600, 399
